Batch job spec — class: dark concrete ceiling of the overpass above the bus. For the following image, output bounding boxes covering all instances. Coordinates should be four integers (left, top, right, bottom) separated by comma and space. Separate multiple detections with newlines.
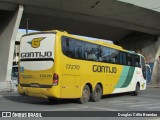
0, 0, 160, 41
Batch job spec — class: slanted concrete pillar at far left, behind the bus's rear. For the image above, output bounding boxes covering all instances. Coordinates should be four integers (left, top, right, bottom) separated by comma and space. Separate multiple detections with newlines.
0, 5, 24, 91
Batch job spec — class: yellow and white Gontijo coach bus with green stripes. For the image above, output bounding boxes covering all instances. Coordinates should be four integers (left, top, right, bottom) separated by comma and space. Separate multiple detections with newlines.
18, 30, 146, 104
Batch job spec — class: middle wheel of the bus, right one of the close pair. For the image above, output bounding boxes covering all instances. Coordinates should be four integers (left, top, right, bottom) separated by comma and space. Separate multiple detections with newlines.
90, 84, 102, 102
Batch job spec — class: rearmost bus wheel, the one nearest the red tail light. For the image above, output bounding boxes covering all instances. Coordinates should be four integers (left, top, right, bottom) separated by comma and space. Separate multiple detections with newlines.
78, 85, 90, 104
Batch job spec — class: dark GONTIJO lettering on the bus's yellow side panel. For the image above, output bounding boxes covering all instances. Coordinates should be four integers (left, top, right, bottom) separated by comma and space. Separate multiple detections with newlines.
92, 65, 117, 73
